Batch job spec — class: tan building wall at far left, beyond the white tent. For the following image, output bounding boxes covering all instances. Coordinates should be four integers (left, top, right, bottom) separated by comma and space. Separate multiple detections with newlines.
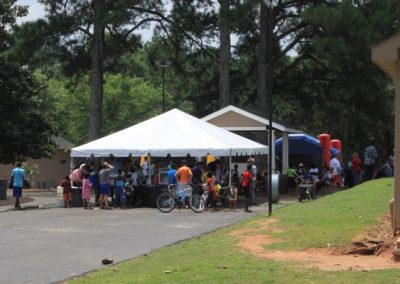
0, 149, 71, 188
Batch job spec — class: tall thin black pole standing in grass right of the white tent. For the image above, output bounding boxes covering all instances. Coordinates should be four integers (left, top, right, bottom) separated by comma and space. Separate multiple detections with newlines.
264, 0, 274, 216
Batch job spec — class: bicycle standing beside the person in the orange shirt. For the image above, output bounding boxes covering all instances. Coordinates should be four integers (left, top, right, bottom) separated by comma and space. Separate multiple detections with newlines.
157, 184, 205, 213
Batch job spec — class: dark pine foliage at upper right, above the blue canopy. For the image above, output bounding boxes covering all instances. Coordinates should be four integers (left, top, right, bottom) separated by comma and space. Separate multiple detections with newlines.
277, 1, 400, 155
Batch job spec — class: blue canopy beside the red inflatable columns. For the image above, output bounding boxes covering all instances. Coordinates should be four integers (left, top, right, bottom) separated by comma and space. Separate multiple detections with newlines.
275, 134, 340, 167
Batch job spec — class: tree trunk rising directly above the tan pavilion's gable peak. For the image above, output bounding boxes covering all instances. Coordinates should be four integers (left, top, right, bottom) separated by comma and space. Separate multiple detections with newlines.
219, 0, 231, 108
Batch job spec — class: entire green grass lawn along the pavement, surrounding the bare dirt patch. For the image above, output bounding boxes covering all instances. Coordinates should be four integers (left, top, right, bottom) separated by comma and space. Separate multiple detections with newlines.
70, 179, 400, 284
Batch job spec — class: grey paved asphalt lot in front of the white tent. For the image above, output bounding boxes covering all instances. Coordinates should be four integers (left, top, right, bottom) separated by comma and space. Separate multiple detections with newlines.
0, 192, 294, 283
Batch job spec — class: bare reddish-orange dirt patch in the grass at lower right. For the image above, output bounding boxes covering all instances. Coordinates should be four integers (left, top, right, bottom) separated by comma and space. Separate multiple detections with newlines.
231, 217, 400, 271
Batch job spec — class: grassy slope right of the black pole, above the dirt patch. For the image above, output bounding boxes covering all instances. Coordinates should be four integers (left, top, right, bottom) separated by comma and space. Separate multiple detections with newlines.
268, 179, 393, 250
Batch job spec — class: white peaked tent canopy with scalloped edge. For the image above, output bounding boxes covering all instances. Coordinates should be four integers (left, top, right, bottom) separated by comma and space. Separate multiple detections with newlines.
71, 109, 268, 157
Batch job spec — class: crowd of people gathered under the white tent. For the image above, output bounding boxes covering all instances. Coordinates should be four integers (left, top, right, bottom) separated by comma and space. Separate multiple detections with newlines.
53, 157, 264, 212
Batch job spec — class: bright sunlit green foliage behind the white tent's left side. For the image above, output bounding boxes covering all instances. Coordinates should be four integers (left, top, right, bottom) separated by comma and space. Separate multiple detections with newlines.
36, 73, 172, 144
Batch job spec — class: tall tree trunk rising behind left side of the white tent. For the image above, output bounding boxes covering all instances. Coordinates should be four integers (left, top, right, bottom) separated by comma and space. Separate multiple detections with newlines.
89, 0, 105, 141
